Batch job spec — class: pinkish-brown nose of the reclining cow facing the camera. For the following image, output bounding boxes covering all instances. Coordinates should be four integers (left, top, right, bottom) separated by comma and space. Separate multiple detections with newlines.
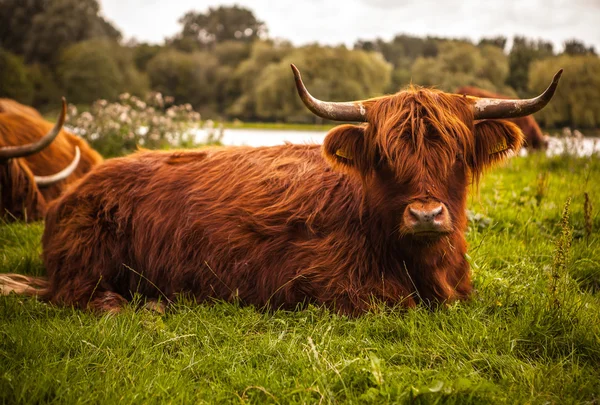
404, 202, 451, 234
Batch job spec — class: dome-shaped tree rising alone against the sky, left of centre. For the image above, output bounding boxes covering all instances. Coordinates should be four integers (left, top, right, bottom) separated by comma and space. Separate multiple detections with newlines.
171, 5, 267, 52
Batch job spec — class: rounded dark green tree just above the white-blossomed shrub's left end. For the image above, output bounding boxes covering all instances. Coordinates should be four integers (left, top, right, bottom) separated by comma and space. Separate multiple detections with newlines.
57, 39, 148, 104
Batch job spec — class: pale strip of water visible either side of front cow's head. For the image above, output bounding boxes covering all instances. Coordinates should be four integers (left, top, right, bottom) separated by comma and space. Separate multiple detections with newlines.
194, 129, 600, 156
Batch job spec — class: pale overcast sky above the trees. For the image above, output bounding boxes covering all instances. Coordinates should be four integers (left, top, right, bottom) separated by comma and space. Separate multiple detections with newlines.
99, 0, 600, 51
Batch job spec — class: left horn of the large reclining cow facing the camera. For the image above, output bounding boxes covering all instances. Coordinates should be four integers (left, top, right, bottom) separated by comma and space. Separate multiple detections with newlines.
291, 64, 367, 122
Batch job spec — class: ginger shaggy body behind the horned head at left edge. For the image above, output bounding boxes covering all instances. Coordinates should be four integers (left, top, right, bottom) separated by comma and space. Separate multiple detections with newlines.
0, 98, 103, 201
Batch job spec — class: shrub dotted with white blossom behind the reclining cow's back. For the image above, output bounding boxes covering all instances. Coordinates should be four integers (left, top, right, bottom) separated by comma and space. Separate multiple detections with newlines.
68, 92, 218, 157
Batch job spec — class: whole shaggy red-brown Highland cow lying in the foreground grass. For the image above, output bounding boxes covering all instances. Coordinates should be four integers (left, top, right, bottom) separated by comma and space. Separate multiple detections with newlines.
0, 66, 560, 315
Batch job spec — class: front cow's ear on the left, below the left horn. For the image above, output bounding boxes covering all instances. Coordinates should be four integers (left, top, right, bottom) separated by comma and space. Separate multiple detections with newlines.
323, 124, 372, 175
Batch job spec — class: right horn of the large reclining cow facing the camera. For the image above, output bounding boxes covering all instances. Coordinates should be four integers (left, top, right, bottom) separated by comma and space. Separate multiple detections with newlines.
473, 69, 563, 120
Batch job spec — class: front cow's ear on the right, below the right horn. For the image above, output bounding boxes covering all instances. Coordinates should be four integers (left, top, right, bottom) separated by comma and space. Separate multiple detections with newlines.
472, 120, 523, 173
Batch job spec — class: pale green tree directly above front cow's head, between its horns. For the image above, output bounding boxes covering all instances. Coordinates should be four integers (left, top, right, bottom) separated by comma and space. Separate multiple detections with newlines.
411, 41, 508, 92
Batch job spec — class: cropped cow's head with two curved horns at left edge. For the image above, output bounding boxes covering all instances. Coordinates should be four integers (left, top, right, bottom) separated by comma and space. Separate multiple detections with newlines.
0, 99, 80, 220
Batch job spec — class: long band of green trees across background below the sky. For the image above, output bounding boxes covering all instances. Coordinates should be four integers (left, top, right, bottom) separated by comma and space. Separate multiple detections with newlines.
0, 0, 600, 128
